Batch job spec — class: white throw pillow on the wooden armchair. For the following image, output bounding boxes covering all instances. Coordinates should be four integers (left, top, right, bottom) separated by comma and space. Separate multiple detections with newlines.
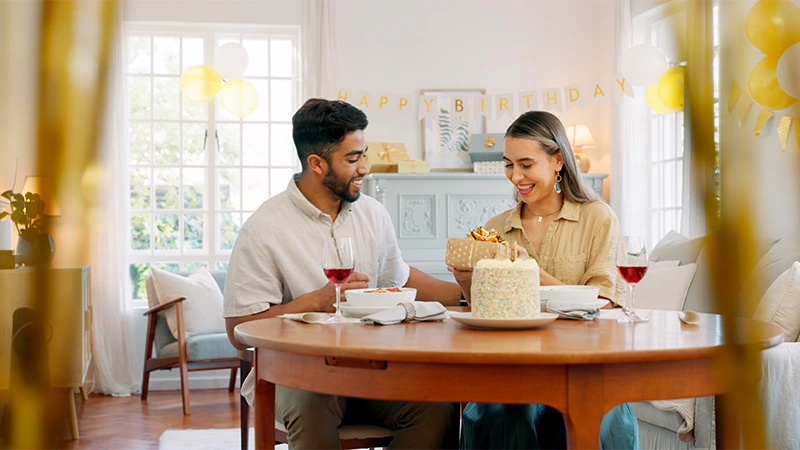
150, 267, 225, 339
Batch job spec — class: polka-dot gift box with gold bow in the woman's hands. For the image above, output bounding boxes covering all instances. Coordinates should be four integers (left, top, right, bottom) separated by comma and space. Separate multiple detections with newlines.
444, 227, 516, 270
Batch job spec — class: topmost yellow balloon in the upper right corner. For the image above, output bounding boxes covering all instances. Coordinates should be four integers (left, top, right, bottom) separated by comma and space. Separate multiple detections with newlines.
744, 0, 800, 58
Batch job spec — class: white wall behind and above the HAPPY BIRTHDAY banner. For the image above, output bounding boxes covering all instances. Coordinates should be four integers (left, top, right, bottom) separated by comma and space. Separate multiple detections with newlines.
336, 0, 614, 191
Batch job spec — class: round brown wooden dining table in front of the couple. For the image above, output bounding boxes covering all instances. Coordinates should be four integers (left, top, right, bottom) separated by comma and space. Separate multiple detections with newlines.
235, 311, 783, 449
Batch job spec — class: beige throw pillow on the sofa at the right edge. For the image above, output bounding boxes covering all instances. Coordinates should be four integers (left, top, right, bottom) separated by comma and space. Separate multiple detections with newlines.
753, 261, 800, 342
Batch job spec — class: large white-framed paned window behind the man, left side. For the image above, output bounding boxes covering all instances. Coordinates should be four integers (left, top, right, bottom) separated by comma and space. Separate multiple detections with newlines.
125, 24, 300, 300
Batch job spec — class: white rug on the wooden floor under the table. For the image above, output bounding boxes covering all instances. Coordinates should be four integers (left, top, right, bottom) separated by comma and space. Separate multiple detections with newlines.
158, 428, 289, 450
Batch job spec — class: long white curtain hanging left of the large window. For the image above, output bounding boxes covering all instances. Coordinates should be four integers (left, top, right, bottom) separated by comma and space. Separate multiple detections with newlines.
92, 7, 141, 396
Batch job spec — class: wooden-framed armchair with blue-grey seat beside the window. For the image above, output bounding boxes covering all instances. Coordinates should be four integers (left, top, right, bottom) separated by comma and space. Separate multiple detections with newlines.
142, 271, 244, 416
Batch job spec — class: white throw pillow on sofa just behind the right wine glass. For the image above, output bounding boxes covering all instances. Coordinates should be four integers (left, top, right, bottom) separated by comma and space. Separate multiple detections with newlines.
633, 263, 697, 311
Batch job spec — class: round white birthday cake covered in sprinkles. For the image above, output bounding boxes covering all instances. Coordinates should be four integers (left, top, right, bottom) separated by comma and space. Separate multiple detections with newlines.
471, 259, 541, 319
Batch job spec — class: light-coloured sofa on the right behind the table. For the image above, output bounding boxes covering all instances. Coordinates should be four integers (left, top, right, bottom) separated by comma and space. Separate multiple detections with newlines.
633, 231, 800, 449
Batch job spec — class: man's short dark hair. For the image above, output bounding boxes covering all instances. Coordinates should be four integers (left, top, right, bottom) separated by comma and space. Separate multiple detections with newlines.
292, 98, 369, 171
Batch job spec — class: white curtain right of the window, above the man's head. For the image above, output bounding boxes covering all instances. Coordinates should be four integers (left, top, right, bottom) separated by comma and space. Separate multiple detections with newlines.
301, 0, 339, 102
